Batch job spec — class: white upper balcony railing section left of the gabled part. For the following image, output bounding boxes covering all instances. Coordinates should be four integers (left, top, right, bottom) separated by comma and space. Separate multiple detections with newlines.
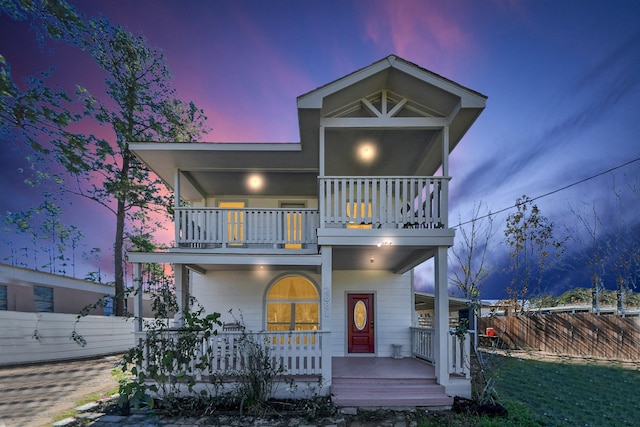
176, 208, 319, 248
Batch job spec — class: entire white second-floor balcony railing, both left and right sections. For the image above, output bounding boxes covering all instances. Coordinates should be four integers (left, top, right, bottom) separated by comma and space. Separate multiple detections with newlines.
175, 177, 448, 252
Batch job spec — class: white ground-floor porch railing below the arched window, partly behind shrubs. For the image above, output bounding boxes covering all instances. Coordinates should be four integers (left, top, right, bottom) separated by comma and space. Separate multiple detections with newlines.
137, 330, 324, 379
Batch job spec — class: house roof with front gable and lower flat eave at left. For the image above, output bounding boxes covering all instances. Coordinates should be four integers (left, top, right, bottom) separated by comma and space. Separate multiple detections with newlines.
130, 55, 486, 200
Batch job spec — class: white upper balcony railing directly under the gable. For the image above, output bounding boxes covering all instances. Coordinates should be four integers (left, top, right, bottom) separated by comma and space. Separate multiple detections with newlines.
319, 176, 449, 228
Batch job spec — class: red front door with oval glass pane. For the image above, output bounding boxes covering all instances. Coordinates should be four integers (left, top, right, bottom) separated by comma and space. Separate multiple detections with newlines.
347, 294, 375, 353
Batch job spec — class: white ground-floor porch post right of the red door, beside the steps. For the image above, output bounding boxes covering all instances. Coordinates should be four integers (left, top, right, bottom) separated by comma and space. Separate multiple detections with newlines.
434, 246, 451, 386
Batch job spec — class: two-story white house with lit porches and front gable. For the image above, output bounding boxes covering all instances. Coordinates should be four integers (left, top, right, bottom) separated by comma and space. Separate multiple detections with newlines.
128, 56, 486, 406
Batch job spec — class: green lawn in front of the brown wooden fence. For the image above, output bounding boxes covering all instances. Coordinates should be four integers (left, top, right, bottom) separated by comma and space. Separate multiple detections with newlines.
493, 356, 640, 427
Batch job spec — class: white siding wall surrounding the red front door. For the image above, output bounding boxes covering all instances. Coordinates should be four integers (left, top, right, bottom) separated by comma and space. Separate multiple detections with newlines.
331, 270, 412, 357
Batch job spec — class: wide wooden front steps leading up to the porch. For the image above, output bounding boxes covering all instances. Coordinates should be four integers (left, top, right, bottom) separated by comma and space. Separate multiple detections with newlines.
331, 376, 453, 408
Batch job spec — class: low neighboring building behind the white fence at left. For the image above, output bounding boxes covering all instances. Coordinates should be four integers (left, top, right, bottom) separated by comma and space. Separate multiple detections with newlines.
0, 264, 114, 315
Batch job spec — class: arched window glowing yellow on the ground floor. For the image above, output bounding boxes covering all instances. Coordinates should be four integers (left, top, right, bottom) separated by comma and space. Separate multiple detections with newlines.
267, 276, 320, 331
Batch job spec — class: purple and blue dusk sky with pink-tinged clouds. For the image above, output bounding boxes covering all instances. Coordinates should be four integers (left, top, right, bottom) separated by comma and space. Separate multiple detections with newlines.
0, 0, 640, 298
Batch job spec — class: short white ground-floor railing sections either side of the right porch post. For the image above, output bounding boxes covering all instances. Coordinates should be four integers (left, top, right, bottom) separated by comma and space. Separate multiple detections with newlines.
411, 328, 471, 378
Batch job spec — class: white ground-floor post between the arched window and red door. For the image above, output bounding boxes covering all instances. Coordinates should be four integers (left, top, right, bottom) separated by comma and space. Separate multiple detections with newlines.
320, 246, 333, 393
